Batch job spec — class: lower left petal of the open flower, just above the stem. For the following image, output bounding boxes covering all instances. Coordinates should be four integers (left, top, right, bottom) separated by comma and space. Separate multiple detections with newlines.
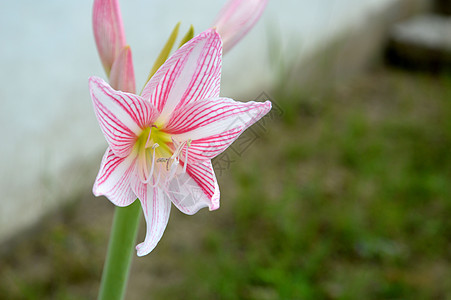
92, 148, 136, 206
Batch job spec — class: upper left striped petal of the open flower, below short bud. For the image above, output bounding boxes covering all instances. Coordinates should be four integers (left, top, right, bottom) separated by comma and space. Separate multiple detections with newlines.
89, 77, 158, 157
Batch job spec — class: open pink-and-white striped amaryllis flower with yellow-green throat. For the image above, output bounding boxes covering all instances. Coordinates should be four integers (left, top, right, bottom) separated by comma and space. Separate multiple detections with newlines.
89, 29, 271, 256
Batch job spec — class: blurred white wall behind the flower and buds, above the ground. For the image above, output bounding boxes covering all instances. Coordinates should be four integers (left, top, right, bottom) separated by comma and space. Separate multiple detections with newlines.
0, 0, 395, 240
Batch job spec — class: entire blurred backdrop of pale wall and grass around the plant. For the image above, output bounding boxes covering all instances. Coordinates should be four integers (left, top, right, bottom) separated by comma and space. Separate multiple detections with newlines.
0, 0, 451, 299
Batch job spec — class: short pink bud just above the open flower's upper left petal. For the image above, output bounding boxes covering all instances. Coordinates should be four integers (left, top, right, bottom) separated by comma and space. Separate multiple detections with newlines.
110, 46, 135, 93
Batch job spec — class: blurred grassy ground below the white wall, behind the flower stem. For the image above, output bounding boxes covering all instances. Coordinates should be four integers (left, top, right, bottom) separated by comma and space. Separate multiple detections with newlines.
0, 69, 451, 299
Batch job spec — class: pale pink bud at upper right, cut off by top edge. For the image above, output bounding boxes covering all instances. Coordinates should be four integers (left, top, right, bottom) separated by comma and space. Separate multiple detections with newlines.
214, 0, 268, 53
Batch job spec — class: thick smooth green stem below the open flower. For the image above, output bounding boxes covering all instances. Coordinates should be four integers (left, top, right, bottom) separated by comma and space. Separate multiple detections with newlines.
97, 200, 141, 300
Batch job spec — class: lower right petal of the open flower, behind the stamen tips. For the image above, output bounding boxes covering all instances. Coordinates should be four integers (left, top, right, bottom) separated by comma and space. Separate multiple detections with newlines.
167, 160, 220, 215
